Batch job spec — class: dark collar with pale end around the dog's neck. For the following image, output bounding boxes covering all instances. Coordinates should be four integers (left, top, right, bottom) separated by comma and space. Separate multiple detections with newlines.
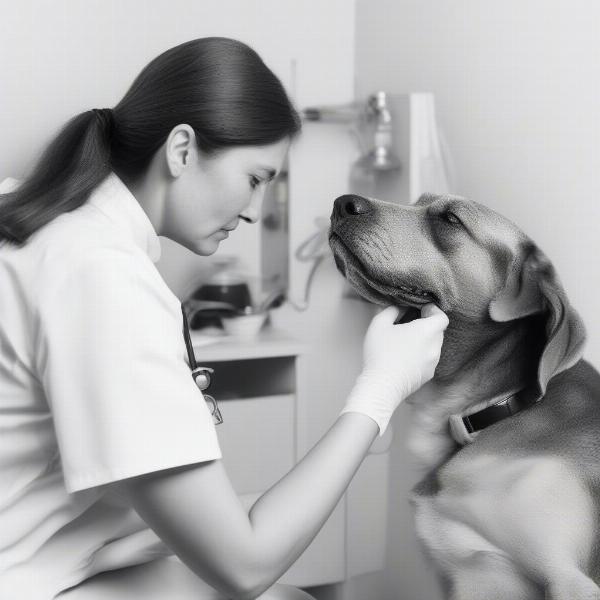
449, 389, 539, 445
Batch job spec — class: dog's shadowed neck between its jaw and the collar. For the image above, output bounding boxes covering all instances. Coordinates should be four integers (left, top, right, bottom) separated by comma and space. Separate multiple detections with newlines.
407, 315, 543, 467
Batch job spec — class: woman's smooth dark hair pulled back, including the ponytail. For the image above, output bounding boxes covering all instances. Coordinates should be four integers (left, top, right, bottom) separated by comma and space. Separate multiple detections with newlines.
0, 37, 300, 245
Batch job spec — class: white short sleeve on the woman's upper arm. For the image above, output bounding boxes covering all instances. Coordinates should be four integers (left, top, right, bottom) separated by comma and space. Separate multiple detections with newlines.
38, 248, 221, 492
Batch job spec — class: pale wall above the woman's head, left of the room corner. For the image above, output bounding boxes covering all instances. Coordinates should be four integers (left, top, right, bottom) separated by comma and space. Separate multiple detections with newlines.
0, 0, 354, 170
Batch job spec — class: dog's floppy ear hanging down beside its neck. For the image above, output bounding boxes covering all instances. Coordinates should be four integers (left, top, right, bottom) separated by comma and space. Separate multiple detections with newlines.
489, 243, 585, 394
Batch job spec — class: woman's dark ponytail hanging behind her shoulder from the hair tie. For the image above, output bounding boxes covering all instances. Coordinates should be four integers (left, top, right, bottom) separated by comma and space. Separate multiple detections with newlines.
0, 108, 112, 246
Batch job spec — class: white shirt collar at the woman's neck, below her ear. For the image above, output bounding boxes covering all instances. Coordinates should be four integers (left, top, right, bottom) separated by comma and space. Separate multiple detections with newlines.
88, 171, 161, 263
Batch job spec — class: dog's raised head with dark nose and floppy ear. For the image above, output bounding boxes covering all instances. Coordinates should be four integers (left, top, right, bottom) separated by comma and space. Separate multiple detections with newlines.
329, 194, 585, 393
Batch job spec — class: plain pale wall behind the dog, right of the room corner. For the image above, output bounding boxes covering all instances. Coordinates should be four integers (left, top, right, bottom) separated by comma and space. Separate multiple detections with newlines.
356, 0, 600, 600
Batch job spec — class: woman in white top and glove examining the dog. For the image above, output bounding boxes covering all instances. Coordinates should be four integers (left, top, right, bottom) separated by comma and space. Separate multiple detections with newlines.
0, 38, 447, 600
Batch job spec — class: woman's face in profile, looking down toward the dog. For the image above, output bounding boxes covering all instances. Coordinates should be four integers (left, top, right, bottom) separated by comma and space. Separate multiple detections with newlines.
161, 138, 290, 256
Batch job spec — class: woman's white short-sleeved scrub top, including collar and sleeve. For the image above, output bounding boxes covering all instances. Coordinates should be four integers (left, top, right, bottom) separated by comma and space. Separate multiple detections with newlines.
0, 173, 221, 600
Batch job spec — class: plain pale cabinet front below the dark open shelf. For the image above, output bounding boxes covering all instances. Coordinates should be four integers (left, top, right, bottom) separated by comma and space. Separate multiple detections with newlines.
217, 394, 295, 494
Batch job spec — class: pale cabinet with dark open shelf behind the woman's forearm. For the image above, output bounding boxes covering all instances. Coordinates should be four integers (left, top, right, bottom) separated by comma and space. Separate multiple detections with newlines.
191, 328, 346, 587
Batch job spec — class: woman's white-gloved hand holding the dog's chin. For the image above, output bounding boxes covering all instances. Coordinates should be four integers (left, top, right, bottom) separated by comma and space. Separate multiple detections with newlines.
340, 304, 448, 435
